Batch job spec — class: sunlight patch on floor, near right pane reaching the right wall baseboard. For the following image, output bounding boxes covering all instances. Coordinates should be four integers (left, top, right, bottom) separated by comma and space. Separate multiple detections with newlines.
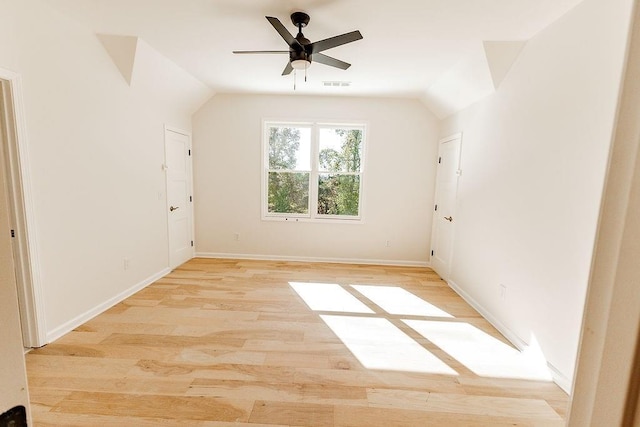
403, 320, 551, 381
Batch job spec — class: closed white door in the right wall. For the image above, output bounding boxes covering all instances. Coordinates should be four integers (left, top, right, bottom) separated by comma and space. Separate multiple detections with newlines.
431, 134, 462, 280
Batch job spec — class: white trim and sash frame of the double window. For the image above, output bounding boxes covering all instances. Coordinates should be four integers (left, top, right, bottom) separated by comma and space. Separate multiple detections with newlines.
260, 119, 369, 224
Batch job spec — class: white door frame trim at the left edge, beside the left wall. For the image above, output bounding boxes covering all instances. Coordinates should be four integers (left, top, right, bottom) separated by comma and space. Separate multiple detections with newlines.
0, 68, 47, 348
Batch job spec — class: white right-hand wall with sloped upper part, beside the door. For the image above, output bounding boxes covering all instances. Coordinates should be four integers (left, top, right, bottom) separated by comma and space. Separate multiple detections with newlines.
441, 0, 632, 389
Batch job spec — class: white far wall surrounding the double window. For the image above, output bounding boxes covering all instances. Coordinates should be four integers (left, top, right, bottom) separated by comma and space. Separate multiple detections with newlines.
193, 94, 437, 264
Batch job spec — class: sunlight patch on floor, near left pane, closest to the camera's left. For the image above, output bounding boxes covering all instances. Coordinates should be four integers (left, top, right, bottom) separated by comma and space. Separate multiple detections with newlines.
320, 315, 458, 375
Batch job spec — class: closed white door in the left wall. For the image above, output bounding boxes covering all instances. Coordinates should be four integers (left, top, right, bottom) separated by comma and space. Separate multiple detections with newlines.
165, 129, 193, 269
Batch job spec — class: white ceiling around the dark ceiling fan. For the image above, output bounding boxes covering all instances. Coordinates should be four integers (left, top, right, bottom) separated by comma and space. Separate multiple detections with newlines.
47, 0, 581, 103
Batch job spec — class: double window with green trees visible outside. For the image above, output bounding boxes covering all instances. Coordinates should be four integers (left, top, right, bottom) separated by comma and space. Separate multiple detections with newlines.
262, 122, 365, 220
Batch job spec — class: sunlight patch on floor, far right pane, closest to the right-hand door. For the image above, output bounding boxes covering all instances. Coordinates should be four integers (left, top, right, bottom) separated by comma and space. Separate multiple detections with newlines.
351, 285, 453, 317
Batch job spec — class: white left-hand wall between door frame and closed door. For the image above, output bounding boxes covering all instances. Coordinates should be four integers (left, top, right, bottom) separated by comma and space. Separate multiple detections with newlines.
0, 0, 207, 339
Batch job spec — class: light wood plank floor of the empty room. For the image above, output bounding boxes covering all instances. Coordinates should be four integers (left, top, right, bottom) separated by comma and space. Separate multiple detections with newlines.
27, 259, 567, 427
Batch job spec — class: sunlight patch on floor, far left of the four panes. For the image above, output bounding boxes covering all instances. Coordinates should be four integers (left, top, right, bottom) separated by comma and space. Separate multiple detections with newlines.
289, 282, 373, 314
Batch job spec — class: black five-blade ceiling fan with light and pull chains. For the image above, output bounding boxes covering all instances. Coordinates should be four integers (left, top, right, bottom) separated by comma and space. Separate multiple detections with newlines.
233, 12, 362, 76
